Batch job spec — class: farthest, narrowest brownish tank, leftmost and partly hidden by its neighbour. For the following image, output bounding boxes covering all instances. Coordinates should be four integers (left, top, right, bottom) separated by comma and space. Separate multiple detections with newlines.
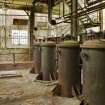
33, 42, 41, 73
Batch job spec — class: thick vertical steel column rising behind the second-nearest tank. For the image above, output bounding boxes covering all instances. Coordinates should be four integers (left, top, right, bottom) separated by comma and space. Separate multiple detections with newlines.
71, 0, 78, 37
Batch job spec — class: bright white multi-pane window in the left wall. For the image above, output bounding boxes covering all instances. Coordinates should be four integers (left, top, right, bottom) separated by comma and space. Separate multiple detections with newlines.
12, 30, 28, 45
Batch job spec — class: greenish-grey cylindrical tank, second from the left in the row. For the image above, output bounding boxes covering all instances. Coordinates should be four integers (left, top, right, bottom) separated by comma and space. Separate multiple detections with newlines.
41, 42, 56, 81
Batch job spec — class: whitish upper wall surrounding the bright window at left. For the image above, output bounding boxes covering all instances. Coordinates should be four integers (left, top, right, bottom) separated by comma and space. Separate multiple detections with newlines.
0, 9, 29, 48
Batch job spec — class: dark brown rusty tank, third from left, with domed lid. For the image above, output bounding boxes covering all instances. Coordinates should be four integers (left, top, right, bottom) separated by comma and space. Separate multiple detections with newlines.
57, 41, 81, 97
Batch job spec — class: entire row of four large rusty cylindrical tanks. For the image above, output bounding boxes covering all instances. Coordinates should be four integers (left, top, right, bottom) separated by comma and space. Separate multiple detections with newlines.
34, 39, 105, 105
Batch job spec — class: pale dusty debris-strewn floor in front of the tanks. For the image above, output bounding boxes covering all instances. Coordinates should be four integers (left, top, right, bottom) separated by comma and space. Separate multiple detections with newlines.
0, 70, 80, 105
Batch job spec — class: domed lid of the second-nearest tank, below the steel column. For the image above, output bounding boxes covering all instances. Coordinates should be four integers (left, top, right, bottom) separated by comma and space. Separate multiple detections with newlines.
57, 40, 80, 47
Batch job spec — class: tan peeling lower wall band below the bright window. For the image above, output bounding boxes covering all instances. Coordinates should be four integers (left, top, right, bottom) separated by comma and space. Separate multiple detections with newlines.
0, 49, 29, 64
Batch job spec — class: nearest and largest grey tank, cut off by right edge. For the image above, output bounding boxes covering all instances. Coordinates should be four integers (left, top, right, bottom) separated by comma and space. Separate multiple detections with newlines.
81, 39, 105, 105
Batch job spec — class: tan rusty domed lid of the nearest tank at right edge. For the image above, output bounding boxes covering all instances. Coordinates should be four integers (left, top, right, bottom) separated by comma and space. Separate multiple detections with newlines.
81, 39, 105, 48
